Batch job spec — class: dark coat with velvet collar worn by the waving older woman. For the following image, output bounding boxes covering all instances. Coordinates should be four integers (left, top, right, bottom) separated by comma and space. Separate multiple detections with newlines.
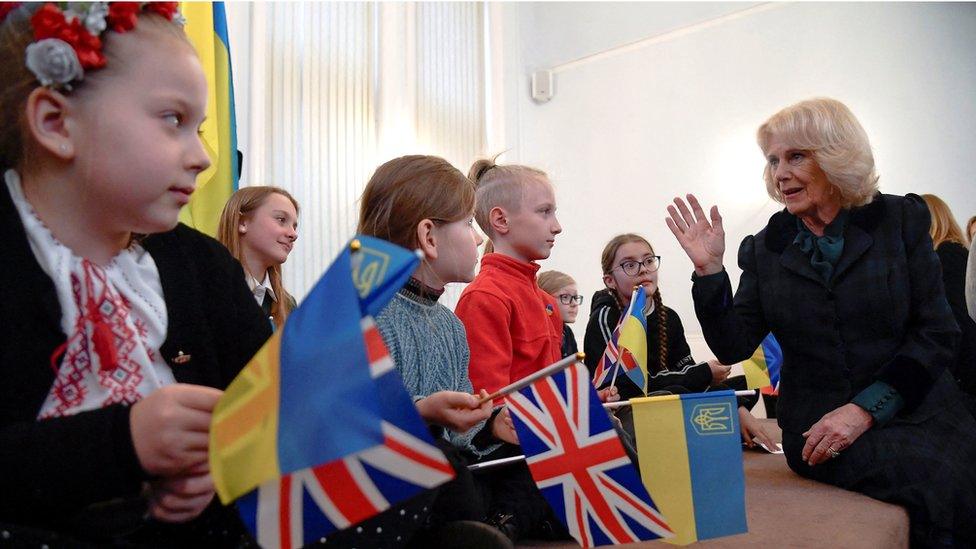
692, 194, 959, 433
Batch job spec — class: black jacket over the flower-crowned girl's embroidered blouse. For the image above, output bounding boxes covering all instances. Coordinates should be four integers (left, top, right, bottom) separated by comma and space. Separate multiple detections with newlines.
0, 182, 271, 530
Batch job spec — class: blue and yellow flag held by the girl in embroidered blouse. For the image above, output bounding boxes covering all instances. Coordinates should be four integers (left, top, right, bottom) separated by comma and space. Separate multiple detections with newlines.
210, 236, 419, 503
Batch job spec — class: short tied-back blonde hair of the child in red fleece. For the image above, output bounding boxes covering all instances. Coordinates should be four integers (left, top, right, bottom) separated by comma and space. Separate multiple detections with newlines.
468, 155, 548, 253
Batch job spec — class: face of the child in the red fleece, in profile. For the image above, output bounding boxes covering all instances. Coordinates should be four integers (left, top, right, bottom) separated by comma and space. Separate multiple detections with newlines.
504, 179, 563, 261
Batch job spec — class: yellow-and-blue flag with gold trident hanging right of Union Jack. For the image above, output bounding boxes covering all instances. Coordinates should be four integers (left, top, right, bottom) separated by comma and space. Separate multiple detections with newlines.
631, 391, 747, 545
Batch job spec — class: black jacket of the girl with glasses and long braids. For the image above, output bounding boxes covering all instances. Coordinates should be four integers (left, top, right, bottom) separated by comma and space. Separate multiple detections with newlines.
583, 290, 712, 399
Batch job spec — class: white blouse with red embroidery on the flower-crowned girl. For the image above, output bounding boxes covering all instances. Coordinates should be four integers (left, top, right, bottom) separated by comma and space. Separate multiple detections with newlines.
4, 170, 176, 419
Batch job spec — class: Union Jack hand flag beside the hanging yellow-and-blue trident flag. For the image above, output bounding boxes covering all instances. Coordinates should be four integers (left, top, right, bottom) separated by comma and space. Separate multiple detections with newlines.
506, 364, 673, 547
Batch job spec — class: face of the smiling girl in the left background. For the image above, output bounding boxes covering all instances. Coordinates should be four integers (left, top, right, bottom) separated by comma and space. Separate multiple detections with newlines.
237, 193, 298, 270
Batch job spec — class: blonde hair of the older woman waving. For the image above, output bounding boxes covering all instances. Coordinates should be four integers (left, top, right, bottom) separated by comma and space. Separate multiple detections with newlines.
756, 97, 878, 208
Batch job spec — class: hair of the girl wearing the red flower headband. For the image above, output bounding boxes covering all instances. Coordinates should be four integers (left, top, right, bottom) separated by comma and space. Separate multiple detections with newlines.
0, 7, 192, 171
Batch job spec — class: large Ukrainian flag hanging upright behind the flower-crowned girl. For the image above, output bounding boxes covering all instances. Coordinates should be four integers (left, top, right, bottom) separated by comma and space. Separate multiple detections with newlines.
180, 2, 240, 236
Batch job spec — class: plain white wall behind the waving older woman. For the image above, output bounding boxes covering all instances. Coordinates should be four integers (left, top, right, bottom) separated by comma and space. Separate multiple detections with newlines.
504, 3, 976, 358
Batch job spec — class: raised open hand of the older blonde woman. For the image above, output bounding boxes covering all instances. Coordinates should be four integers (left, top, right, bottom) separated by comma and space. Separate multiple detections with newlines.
664, 194, 725, 276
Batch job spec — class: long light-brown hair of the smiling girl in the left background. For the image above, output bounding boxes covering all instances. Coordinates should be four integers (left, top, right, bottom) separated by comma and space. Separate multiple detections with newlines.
217, 186, 298, 328
